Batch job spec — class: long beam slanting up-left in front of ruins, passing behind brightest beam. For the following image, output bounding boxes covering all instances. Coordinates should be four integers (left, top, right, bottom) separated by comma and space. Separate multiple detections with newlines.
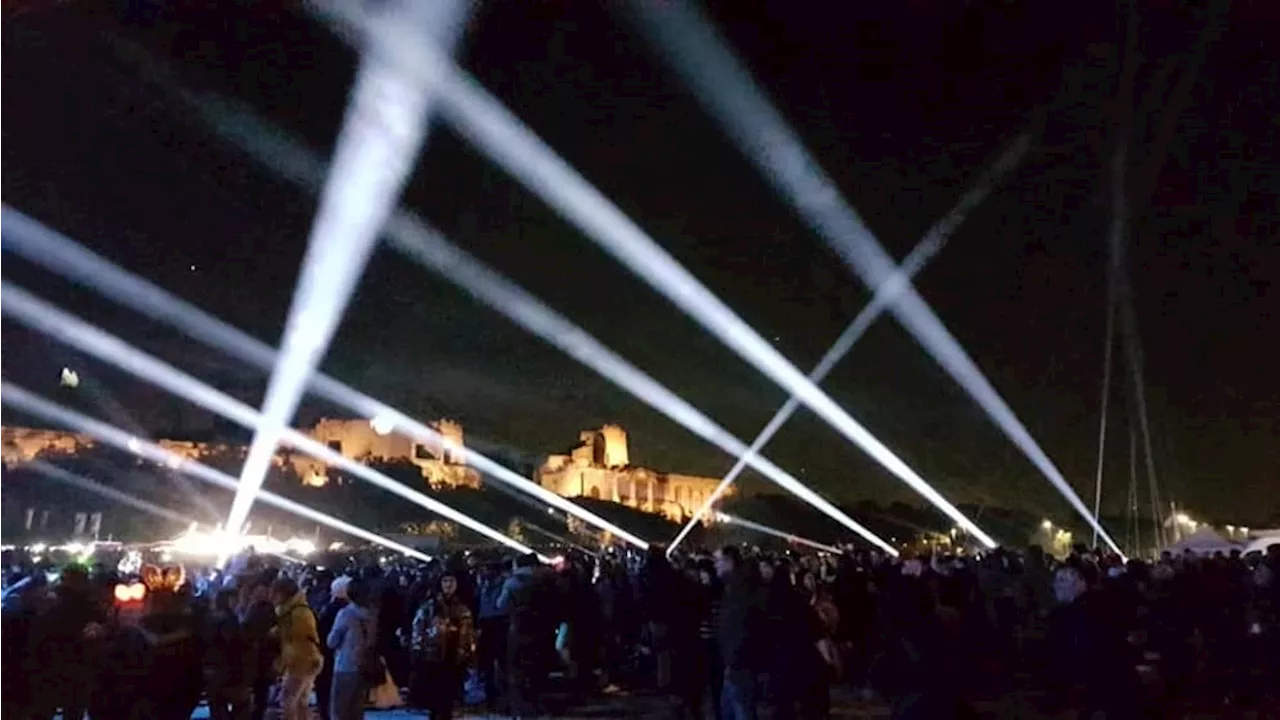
137, 88, 897, 548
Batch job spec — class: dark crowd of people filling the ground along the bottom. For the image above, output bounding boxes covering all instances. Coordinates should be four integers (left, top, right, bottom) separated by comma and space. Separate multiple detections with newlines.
0, 547, 1280, 720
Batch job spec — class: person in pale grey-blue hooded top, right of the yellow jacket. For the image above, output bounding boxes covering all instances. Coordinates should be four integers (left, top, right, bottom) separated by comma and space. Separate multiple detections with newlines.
325, 578, 378, 720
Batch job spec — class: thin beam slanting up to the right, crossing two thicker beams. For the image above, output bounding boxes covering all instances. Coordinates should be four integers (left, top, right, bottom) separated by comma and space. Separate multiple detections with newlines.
667, 136, 1030, 548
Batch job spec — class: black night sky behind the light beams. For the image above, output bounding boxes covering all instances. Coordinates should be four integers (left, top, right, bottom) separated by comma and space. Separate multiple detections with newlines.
0, 0, 1280, 523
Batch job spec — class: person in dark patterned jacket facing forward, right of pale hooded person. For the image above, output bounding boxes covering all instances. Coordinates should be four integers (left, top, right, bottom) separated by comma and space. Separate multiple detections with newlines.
410, 573, 476, 720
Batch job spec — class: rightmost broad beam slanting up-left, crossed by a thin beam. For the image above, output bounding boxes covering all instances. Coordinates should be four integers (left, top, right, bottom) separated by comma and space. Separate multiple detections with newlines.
629, 0, 1120, 553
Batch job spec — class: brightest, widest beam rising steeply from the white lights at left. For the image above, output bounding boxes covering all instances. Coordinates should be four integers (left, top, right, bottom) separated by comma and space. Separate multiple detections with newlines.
225, 0, 470, 533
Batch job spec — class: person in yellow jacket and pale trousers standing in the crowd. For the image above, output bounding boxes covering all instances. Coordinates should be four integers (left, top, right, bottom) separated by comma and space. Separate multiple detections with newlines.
271, 578, 324, 720
